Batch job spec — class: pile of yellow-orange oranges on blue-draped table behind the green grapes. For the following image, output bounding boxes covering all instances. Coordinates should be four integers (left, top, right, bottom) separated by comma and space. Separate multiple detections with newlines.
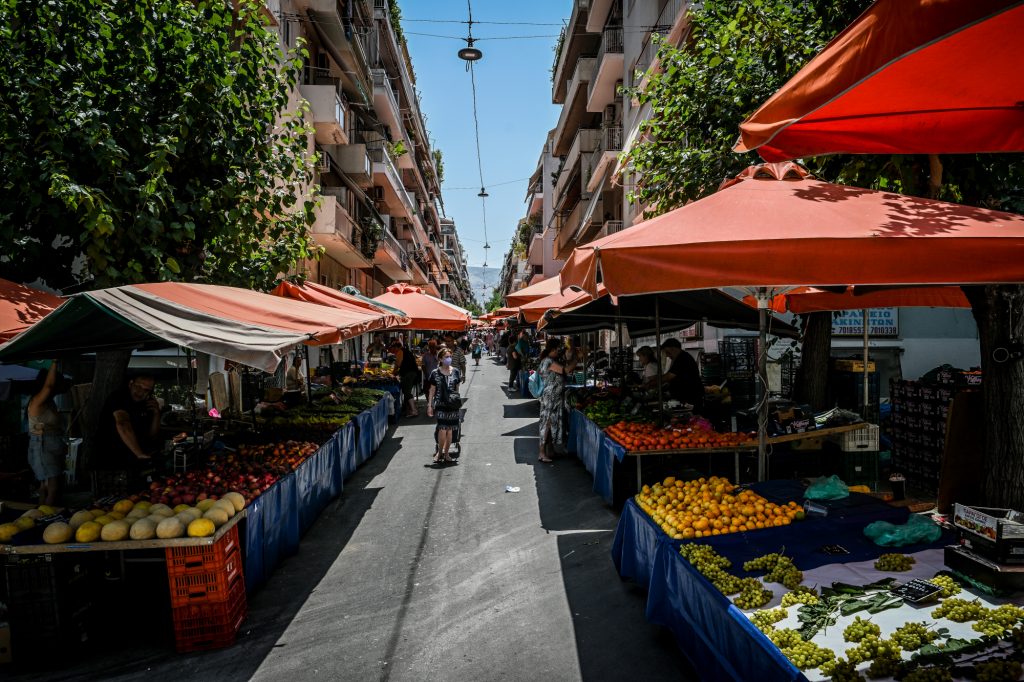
635, 476, 804, 540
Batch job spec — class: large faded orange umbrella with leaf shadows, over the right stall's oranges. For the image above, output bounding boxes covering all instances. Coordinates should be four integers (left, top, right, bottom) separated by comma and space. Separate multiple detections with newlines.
559, 163, 1024, 296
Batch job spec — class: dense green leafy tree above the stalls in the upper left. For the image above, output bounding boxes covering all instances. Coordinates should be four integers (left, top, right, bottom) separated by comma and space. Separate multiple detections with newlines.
0, 0, 315, 289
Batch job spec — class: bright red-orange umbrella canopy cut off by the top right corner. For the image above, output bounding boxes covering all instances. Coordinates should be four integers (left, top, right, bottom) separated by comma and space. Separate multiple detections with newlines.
735, 0, 1024, 161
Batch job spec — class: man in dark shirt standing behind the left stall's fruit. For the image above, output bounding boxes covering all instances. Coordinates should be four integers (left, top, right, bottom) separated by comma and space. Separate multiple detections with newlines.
95, 375, 160, 469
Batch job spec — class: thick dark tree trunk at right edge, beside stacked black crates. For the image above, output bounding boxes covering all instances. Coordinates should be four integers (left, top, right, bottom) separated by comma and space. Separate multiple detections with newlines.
964, 285, 1024, 510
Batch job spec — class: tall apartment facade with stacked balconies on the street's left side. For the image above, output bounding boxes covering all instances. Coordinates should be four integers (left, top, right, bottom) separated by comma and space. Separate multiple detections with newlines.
267, 0, 472, 305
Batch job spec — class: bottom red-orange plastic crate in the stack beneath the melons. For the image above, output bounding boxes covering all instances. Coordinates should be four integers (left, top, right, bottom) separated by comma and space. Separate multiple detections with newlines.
171, 574, 248, 653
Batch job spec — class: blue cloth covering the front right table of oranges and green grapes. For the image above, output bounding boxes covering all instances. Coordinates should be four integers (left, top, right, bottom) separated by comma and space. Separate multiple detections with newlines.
611, 481, 951, 680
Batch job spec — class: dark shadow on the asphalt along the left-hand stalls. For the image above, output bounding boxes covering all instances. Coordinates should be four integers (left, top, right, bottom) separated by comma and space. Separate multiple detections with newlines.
12, 426, 401, 682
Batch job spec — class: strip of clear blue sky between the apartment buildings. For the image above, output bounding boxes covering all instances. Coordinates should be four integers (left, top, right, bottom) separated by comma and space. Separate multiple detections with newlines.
398, 0, 572, 303
